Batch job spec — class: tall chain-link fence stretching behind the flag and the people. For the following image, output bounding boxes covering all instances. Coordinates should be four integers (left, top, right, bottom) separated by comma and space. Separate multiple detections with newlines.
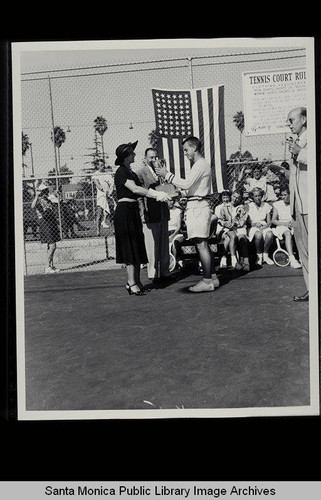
21, 47, 305, 274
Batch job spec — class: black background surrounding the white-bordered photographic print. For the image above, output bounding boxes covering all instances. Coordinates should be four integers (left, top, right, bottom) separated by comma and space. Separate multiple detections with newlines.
0, 17, 321, 482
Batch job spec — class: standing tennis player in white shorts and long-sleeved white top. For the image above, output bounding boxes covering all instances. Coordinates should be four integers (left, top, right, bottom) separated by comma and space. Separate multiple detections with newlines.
156, 136, 220, 292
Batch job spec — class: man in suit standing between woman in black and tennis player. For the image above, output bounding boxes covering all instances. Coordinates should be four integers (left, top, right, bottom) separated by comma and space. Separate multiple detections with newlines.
136, 148, 173, 280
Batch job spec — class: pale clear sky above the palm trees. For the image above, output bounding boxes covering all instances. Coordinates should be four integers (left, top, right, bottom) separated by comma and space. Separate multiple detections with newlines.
15, 39, 312, 180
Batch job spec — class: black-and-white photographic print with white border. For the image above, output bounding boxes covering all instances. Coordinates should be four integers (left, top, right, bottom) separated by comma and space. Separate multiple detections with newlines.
12, 37, 319, 421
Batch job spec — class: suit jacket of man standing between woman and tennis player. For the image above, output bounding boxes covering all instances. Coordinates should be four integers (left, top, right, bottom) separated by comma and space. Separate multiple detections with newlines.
136, 165, 169, 222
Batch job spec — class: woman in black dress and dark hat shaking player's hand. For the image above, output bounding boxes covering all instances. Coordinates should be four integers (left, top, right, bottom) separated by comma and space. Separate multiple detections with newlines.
114, 141, 171, 295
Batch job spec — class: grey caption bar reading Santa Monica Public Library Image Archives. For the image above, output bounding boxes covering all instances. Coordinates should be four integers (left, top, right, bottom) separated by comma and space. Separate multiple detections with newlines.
0, 481, 321, 500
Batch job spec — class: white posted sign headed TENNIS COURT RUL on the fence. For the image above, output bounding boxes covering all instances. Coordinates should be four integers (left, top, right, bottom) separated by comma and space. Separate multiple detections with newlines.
243, 68, 307, 136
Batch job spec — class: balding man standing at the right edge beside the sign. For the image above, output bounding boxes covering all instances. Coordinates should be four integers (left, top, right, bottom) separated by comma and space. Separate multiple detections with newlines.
287, 107, 309, 302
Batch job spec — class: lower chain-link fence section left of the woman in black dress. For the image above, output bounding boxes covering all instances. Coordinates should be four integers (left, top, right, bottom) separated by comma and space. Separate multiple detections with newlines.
23, 174, 117, 274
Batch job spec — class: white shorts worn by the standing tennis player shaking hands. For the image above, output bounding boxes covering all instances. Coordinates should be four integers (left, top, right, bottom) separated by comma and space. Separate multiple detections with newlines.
185, 201, 213, 239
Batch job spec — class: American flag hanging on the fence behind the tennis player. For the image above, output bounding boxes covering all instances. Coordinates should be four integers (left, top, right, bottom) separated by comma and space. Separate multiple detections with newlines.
152, 85, 228, 193
